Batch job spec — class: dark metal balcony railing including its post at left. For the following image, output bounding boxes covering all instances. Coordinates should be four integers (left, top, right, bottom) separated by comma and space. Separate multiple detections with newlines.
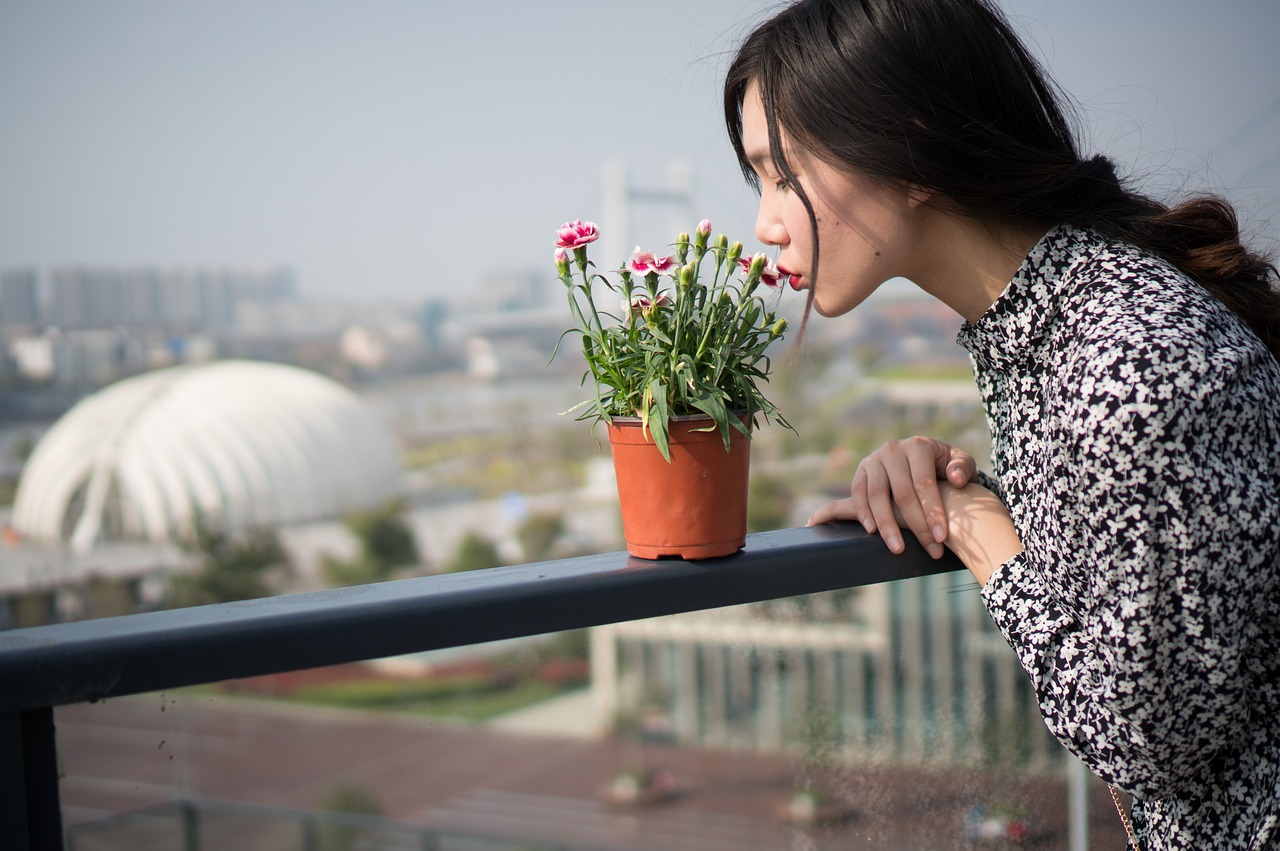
0, 523, 963, 850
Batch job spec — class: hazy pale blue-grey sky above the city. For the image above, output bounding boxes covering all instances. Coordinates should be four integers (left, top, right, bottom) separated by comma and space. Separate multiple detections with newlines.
0, 0, 1280, 298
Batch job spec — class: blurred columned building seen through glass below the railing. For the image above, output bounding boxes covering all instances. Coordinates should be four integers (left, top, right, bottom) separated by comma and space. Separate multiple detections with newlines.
591, 575, 1065, 772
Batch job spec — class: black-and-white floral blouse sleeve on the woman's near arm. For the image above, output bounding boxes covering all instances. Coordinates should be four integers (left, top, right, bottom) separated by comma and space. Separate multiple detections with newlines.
982, 337, 1280, 800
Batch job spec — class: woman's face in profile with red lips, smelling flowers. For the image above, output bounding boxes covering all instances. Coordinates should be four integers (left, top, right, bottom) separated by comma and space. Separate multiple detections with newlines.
742, 83, 925, 316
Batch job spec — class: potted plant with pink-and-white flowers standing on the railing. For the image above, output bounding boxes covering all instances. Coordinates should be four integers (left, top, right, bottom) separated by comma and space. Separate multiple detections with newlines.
552, 220, 791, 558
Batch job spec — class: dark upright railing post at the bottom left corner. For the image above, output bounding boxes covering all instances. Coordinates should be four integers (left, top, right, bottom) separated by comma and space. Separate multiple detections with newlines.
0, 706, 63, 851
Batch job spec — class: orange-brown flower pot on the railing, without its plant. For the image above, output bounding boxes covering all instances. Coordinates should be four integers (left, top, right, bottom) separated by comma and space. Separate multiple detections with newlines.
609, 416, 751, 559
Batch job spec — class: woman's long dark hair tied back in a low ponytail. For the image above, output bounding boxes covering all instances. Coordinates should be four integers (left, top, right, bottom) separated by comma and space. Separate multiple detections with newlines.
724, 0, 1280, 360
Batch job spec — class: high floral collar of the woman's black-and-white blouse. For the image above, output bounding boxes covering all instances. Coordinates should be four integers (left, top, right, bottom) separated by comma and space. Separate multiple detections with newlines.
956, 224, 1103, 372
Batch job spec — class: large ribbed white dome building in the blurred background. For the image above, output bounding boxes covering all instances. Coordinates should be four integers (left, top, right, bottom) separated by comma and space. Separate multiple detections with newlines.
13, 361, 403, 552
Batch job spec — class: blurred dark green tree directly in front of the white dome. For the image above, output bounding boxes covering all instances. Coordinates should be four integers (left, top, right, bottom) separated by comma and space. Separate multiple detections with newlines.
174, 521, 289, 605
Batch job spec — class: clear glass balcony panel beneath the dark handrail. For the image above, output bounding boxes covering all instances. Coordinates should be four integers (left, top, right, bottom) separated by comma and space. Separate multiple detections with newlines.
56, 593, 1124, 851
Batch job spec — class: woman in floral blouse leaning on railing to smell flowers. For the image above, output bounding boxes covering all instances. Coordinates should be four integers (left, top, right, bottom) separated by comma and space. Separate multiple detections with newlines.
724, 0, 1280, 850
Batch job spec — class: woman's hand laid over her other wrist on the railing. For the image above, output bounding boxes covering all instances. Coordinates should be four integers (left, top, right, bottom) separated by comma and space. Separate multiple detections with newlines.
808, 436, 978, 558
